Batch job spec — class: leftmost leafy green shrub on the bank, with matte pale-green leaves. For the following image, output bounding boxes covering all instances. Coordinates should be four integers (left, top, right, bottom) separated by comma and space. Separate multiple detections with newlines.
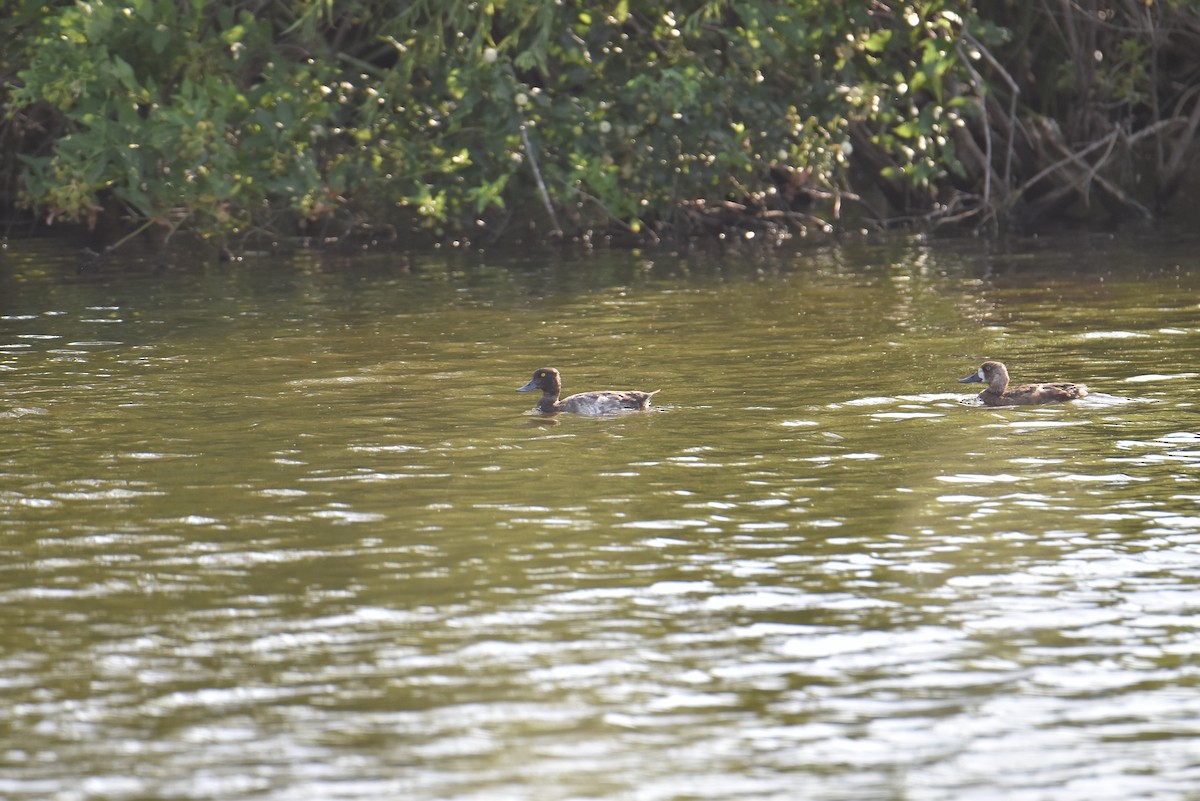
13, 0, 352, 235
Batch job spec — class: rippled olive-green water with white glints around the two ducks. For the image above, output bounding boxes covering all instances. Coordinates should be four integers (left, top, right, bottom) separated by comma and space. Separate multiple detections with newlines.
0, 237, 1200, 801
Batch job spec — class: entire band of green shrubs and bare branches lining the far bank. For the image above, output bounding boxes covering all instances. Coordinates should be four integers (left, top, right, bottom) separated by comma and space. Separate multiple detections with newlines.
0, 0, 1200, 253
